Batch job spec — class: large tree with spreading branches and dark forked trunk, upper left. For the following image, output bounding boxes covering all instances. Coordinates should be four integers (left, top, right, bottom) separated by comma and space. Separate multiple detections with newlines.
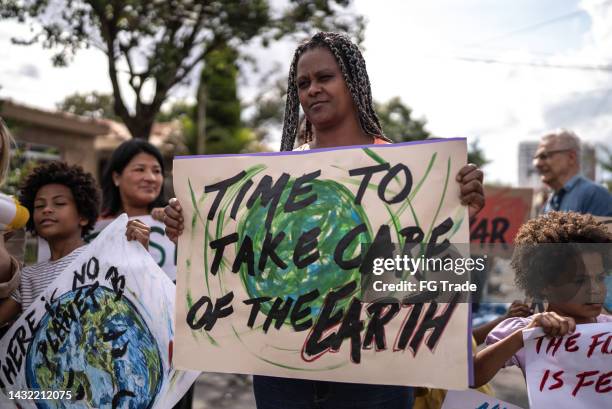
0, 0, 364, 139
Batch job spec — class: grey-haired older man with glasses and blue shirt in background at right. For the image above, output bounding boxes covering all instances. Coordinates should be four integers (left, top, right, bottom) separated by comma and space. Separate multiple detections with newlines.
533, 130, 612, 216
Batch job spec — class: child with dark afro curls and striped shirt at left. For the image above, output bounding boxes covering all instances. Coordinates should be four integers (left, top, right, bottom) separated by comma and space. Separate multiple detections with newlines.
0, 162, 150, 326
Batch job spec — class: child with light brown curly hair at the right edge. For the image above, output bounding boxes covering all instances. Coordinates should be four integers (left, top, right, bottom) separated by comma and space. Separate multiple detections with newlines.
474, 212, 612, 386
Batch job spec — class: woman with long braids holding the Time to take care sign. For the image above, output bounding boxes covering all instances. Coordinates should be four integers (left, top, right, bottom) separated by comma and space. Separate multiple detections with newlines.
164, 33, 484, 409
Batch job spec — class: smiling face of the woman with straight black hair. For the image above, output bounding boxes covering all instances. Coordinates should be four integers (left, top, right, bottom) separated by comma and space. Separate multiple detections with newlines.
113, 152, 164, 208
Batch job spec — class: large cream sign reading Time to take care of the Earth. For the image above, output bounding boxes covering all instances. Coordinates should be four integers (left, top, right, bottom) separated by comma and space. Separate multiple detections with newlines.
173, 139, 471, 389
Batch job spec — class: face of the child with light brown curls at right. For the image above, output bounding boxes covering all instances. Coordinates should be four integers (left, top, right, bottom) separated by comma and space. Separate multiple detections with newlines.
545, 252, 607, 322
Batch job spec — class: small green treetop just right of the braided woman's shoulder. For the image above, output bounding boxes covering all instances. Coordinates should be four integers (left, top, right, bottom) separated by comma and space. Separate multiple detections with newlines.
374, 97, 432, 142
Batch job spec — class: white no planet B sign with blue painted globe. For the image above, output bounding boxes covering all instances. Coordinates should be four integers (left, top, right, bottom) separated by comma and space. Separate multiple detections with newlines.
0, 215, 197, 409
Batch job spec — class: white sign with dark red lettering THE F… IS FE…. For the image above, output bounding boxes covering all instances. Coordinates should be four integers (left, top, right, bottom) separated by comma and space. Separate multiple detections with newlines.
523, 322, 612, 409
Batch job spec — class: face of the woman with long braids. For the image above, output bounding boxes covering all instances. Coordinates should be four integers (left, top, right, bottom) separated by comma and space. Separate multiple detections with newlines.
297, 47, 355, 130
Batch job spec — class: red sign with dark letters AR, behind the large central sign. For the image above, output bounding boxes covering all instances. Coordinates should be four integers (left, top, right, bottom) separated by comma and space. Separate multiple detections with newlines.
470, 186, 533, 255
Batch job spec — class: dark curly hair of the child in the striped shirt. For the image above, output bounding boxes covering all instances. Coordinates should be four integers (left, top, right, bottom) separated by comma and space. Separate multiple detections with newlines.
19, 162, 100, 236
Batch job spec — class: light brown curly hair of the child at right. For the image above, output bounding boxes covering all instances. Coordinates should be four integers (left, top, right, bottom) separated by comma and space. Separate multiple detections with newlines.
511, 212, 612, 299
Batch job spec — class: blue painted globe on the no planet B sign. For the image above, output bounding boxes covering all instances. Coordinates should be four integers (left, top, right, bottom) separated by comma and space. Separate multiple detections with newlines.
25, 287, 163, 409
